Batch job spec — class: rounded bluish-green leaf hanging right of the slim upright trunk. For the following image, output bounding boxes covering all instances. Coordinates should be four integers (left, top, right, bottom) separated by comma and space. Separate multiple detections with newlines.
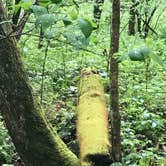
128, 49, 145, 61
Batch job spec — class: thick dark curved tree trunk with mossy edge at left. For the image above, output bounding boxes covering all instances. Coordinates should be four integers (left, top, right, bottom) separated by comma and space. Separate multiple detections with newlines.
0, 1, 79, 166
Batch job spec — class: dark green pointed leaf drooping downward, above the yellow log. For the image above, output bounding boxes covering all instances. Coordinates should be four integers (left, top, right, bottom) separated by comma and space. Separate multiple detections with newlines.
78, 18, 94, 38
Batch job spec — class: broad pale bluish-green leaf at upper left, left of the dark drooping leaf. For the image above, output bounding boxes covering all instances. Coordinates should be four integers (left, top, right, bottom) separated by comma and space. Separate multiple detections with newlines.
35, 14, 55, 29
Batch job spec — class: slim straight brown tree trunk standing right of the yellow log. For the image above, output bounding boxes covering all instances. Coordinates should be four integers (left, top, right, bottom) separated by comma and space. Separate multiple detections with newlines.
110, 0, 121, 161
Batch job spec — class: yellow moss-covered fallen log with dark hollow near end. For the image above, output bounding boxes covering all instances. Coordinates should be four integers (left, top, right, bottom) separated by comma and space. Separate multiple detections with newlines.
77, 70, 110, 166
